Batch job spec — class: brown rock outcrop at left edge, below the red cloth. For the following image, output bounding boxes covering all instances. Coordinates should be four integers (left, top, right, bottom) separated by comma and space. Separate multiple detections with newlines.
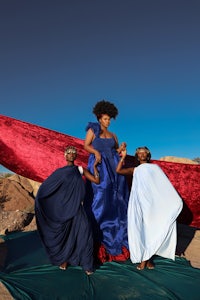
0, 174, 40, 234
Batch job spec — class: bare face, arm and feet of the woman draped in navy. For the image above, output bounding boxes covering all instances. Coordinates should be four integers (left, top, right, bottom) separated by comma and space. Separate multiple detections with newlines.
60, 149, 100, 275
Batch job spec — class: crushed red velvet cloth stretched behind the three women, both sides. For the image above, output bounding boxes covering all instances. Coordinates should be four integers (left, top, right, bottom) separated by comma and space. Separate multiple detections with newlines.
0, 115, 200, 230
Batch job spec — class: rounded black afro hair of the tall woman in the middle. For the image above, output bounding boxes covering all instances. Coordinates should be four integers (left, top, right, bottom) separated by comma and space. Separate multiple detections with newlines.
93, 100, 118, 120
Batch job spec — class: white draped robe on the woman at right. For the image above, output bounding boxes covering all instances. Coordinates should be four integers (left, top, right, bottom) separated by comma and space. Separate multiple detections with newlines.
128, 163, 183, 263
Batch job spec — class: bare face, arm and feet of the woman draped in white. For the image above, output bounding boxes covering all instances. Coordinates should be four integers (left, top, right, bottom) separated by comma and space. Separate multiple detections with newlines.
116, 149, 154, 270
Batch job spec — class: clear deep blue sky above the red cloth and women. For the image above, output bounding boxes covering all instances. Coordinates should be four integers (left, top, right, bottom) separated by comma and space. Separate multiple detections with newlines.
0, 0, 200, 172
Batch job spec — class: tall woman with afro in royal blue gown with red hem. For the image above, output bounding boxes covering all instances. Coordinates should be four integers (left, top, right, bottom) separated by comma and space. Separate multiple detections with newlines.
84, 100, 129, 261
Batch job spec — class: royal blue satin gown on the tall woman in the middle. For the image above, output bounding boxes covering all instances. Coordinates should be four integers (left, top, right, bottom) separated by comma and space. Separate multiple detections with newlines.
84, 122, 129, 255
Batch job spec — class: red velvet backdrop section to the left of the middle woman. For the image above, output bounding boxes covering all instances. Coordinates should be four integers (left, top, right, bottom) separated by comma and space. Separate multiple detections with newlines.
0, 115, 88, 182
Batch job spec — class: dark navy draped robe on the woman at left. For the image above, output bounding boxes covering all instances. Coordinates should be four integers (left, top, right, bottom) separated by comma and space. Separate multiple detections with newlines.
35, 166, 93, 271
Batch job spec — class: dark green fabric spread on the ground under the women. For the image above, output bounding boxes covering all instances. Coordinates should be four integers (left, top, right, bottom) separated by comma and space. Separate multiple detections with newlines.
0, 231, 200, 300
